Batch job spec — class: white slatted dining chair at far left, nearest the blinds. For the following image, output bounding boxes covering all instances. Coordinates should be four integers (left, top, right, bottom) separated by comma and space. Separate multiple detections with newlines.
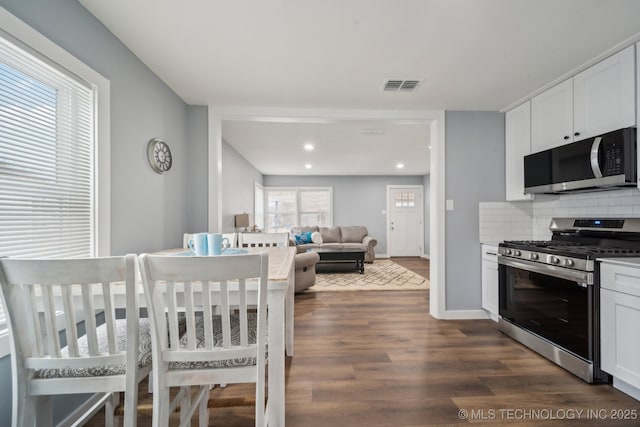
0, 255, 151, 427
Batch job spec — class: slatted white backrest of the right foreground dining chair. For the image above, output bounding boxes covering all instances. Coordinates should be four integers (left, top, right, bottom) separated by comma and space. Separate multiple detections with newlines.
140, 253, 268, 364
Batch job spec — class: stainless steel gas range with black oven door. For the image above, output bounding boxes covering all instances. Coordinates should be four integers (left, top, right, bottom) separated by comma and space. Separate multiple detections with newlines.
498, 218, 640, 383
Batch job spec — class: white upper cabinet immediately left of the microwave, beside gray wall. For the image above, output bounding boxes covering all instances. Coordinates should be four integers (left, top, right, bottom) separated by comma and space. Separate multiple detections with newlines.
505, 101, 533, 201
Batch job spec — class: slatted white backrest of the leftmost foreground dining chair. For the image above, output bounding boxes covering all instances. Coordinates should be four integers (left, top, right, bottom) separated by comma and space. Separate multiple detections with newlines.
0, 255, 138, 369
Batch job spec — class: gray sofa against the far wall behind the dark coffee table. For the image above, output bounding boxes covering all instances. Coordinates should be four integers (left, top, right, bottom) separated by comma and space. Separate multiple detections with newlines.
290, 225, 378, 263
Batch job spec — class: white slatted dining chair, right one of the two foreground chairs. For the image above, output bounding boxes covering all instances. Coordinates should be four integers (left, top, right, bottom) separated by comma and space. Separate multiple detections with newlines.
139, 253, 268, 427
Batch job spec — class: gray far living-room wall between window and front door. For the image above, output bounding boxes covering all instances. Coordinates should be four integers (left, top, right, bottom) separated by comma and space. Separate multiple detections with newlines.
264, 175, 423, 254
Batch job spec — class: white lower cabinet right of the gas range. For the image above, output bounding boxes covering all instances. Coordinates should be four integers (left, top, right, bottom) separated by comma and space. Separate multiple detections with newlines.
600, 262, 640, 399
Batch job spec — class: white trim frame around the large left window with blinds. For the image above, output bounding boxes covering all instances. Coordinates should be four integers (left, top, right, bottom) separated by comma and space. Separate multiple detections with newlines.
0, 8, 111, 357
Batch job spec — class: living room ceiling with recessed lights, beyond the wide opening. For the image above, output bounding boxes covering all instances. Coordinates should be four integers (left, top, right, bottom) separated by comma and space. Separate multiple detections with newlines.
222, 120, 429, 175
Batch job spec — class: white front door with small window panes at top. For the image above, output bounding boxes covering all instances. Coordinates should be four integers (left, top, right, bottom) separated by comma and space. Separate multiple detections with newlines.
387, 185, 424, 256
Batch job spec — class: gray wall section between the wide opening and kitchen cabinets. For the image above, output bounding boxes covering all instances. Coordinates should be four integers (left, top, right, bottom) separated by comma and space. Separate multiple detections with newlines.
445, 111, 505, 310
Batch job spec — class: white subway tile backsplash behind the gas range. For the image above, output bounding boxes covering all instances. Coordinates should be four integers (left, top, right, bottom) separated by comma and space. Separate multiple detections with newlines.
478, 188, 640, 242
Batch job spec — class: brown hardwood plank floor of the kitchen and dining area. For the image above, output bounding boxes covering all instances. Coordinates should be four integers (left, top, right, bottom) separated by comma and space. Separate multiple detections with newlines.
88, 259, 640, 427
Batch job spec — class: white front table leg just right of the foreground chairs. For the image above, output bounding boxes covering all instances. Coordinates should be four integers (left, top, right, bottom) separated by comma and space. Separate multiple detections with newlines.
267, 290, 288, 427
